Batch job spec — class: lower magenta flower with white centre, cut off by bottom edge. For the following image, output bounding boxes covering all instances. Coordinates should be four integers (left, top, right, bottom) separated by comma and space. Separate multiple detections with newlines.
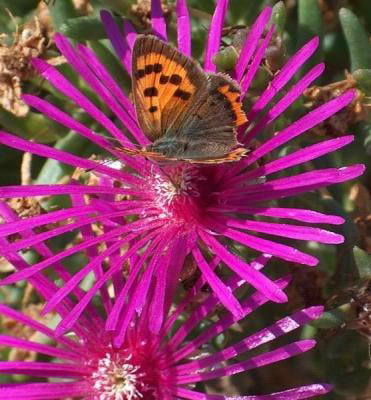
0, 250, 331, 400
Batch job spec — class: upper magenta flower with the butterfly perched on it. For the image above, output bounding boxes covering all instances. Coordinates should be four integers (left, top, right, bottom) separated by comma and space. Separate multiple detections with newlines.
0, 0, 364, 329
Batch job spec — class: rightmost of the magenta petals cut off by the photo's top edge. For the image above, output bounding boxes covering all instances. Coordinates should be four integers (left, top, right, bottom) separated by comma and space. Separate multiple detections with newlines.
204, 0, 229, 72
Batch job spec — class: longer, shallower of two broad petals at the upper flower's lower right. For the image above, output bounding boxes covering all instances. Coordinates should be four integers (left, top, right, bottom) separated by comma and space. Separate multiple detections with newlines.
199, 230, 287, 303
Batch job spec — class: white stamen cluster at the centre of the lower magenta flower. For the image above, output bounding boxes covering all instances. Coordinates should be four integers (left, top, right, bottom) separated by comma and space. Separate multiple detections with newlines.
92, 353, 147, 400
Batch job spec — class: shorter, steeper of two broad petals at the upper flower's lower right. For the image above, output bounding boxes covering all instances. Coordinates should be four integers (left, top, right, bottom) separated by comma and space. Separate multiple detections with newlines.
192, 247, 244, 318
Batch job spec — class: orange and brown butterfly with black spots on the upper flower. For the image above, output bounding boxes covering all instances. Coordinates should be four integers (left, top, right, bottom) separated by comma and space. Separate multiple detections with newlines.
121, 35, 247, 164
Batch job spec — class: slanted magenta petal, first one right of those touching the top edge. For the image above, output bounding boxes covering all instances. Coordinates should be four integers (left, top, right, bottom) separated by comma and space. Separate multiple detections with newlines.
235, 7, 272, 81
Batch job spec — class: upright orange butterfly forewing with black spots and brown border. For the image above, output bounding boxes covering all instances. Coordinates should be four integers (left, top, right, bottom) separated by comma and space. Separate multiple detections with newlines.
132, 35, 206, 141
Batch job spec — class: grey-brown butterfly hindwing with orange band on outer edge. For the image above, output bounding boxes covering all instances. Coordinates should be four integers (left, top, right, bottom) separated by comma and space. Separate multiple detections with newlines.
152, 74, 247, 161
